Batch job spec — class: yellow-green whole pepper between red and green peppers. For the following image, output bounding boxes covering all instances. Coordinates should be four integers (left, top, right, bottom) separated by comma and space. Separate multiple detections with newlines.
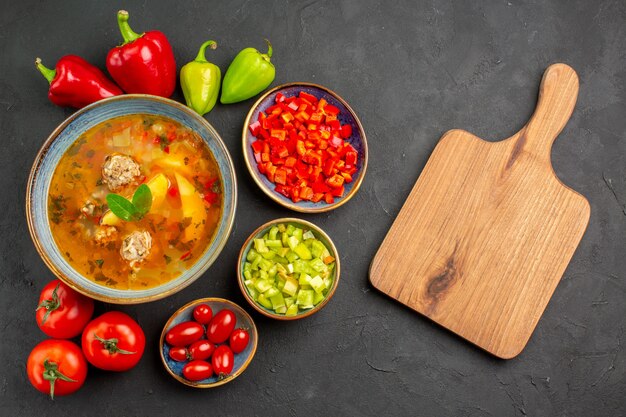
180, 41, 221, 116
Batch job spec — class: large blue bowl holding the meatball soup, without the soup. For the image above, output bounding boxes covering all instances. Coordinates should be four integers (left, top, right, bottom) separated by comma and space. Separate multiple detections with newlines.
26, 94, 237, 304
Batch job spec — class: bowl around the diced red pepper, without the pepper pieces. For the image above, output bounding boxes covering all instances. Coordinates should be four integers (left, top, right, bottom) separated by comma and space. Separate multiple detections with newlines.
242, 82, 368, 213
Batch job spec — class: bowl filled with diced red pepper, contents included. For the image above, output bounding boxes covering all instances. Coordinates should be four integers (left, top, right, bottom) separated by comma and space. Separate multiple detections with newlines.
242, 83, 368, 213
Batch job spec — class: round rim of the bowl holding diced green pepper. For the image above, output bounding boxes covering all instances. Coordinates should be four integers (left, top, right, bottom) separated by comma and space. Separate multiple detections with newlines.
237, 217, 341, 321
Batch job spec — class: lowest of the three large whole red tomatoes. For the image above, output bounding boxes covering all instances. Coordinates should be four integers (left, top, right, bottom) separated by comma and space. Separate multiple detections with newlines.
26, 339, 87, 399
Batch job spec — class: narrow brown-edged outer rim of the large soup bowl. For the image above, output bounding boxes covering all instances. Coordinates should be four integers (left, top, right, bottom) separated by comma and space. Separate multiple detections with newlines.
25, 94, 237, 304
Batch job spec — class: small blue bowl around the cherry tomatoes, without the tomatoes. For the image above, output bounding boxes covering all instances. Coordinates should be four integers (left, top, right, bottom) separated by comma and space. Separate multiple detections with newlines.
159, 298, 259, 388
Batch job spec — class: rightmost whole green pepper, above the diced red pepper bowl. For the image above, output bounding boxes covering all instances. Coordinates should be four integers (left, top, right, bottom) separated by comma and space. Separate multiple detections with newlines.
220, 39, 276, 104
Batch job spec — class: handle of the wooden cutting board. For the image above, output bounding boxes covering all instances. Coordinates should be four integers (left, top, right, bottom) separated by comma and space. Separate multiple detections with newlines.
516, 64, 578, 161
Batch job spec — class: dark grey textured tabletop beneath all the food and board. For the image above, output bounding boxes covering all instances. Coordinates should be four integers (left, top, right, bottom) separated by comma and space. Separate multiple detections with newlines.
0, 0, 626, 416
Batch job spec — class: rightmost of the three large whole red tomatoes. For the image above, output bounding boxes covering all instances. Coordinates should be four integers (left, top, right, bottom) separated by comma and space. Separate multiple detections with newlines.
82, 311, 146, 371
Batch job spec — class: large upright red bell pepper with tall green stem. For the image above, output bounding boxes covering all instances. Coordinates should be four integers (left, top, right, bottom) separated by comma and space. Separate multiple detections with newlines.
107, 10, 176, 97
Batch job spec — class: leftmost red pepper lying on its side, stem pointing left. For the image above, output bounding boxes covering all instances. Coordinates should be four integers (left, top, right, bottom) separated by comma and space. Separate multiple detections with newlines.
35, 55, 123, 109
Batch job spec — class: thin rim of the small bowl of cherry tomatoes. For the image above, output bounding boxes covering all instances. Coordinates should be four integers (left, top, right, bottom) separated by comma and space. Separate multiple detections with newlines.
159, 297, 259, 388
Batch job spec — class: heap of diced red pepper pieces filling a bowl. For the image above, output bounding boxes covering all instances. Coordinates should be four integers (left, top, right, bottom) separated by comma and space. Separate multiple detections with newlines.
247, 91, 358, 204
